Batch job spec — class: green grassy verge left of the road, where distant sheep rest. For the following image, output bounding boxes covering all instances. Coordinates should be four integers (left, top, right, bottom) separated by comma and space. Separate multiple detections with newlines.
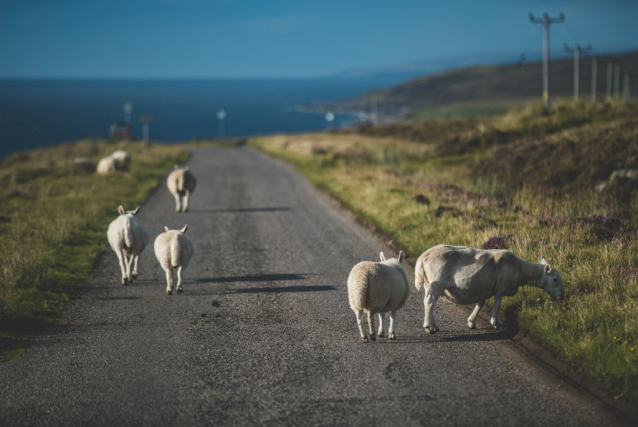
0, 140, 189, 358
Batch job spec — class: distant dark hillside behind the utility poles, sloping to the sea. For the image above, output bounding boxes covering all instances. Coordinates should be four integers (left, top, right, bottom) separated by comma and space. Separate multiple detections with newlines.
339, 52, 638, 113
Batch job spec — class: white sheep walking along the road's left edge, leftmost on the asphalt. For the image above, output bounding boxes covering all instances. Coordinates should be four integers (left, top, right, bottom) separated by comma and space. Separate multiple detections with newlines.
107, 206, 149, 286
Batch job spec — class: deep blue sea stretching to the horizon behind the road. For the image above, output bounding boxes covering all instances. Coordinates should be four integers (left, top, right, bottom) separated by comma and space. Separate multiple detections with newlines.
0, 79, 382, 157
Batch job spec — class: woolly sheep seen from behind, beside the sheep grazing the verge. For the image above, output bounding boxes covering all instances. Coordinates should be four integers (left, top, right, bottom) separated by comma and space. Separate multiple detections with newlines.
348, 251, 410, 343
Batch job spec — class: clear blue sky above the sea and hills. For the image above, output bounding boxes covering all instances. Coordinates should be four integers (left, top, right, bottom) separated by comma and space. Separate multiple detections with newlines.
0, 0, 638, 79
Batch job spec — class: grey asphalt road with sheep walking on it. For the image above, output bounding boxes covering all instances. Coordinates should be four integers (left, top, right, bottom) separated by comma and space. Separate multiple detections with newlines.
0, 148, 632, 427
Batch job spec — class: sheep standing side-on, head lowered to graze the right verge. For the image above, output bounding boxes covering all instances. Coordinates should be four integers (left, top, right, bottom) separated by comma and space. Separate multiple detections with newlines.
414, 245, 564, 334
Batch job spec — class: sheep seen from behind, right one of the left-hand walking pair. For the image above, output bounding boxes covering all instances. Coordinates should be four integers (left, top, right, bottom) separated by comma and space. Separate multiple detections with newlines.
155, 224, 195, 295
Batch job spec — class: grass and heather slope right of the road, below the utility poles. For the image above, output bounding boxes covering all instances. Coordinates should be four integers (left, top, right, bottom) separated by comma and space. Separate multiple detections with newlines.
250, 103, 638, 403
